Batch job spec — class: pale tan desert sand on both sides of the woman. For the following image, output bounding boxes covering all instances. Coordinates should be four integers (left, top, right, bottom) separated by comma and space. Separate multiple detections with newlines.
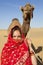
0, 28, 43, 64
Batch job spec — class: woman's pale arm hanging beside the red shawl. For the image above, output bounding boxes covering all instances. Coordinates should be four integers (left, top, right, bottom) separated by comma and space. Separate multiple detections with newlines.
27, 39, 37, 65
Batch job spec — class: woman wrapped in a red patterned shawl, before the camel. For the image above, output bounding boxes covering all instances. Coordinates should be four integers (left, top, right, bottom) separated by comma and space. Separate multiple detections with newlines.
1, 18, 36, 65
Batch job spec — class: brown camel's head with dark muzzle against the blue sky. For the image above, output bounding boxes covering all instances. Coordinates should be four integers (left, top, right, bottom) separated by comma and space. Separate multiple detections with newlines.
21, 4, 34, 20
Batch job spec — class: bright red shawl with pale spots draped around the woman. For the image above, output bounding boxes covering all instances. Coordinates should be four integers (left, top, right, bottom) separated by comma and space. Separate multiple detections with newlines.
1, 35, 32, 65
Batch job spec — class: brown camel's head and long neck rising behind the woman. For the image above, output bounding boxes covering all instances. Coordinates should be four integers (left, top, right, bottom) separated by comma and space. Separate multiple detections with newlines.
21, 4, 34, 37
